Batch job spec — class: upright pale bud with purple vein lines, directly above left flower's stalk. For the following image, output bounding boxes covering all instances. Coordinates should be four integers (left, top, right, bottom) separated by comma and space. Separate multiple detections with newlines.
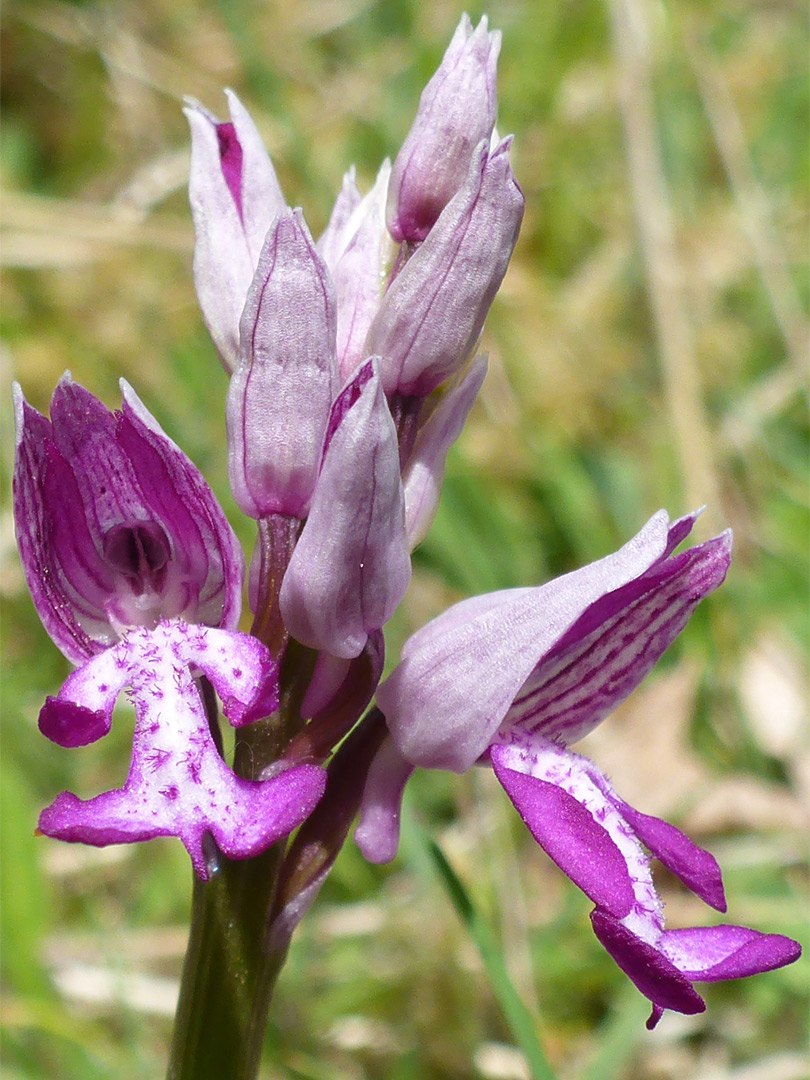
226, 211, 338, 518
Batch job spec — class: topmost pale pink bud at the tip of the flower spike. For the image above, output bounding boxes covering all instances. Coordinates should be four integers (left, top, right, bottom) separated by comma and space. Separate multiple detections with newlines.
387, 15, 501, 243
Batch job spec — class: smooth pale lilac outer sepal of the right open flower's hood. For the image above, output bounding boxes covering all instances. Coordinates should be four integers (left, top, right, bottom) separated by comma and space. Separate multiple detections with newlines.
377, 511, 667, 772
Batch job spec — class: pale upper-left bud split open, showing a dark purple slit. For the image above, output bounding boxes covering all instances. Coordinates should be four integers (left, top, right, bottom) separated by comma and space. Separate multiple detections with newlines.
184, 91, 285, 372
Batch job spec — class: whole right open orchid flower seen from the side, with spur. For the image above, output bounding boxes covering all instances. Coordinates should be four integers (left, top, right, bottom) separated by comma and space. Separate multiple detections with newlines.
355, 512, 800, 1026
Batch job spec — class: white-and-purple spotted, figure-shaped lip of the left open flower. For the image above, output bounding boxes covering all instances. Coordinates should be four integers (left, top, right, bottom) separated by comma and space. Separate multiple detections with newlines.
39, 621, 326, 880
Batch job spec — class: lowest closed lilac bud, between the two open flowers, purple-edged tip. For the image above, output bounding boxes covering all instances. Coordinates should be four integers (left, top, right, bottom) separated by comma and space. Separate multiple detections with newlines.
280, 362, 410, 658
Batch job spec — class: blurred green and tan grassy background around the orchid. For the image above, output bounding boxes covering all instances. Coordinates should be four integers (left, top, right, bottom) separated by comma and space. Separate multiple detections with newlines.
0, 0, 809, 1080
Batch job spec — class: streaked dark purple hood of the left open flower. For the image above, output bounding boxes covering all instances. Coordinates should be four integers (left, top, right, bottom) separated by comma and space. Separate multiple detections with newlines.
14, 375, 244, 664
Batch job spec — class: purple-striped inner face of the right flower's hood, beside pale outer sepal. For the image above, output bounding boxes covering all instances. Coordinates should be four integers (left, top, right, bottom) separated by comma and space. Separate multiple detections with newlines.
505, 534, 731, 745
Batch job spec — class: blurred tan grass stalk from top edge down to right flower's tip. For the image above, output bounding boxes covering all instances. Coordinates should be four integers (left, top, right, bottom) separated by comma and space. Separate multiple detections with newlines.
607, 0, 718, 524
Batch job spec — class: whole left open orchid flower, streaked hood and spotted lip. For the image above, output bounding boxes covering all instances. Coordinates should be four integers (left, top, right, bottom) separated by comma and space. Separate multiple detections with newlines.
14, 376, 325, 878
